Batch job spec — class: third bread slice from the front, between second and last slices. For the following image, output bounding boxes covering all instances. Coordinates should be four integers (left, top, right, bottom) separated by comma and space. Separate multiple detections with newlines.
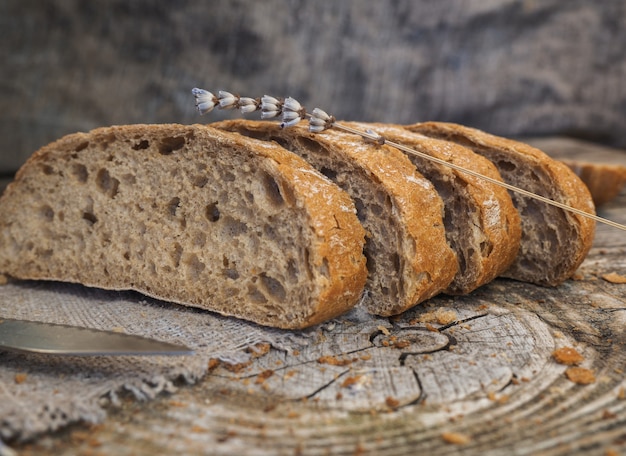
343, 122, 521, 294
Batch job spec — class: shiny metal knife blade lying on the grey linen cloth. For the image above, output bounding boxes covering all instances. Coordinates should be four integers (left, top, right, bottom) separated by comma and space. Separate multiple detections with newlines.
0, 317, 193, 356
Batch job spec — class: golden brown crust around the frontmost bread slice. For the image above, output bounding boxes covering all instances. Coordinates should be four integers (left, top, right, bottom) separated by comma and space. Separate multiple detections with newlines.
0, 124, 367, 328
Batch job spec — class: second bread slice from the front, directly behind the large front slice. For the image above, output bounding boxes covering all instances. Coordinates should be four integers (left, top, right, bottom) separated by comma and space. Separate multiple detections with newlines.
212, 120, 457, 316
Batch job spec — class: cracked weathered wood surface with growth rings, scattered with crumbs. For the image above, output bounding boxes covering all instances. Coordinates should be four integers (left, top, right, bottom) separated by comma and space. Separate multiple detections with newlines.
12, 140, 626, 455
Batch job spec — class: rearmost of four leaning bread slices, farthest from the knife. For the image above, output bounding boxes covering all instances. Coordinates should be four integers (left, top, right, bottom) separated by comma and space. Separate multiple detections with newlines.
406, 122, 595, 286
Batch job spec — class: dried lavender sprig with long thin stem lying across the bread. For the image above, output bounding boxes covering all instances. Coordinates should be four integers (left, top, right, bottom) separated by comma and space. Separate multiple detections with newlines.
192, 89, 626, 231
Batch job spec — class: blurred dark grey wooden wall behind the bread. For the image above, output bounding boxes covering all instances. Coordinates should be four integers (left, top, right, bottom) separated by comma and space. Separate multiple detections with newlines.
0, 0, 626, 175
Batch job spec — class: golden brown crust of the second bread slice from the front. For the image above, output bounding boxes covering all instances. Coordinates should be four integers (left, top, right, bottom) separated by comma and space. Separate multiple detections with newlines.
212, 120, 457, 316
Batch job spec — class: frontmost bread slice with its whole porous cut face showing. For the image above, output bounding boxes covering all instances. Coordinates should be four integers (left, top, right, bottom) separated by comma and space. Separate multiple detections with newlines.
0, 125, 367, 328
